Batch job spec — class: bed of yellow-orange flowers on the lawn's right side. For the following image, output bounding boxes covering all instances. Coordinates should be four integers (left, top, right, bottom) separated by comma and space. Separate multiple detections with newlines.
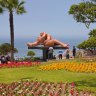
39, 62, 96, 72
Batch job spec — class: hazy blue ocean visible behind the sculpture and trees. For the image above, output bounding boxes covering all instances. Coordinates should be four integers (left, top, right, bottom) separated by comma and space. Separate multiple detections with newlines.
0, 38, 85, 58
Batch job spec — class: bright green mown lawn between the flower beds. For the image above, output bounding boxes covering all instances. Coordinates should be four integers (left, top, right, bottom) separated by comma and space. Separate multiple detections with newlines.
0, 61, 96, 92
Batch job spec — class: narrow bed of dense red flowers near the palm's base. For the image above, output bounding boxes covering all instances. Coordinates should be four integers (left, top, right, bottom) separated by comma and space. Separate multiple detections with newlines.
0, 62, 40, 68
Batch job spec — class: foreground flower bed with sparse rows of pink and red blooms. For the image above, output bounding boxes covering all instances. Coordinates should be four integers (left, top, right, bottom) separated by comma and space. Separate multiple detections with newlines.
0, 80, 93, 96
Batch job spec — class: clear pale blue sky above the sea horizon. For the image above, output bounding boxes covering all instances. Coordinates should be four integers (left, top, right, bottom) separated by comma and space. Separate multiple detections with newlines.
0, 0, 95, 39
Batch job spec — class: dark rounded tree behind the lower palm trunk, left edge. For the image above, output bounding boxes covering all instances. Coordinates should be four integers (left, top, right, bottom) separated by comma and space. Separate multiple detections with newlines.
0, 43, 18, 55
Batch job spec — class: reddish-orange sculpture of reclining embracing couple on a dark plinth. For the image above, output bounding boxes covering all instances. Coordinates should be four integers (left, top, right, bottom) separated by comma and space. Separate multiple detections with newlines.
27, 32, 69, 49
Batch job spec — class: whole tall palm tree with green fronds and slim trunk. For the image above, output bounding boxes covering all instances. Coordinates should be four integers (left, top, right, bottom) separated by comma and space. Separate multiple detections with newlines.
0, 0, 26, 61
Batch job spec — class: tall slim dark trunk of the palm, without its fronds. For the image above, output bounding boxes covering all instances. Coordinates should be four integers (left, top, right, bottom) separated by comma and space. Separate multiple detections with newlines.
9, 12, 14, 61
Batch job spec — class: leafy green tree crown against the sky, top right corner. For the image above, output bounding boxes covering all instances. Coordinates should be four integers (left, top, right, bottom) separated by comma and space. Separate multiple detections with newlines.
69, 0, 96, 28
